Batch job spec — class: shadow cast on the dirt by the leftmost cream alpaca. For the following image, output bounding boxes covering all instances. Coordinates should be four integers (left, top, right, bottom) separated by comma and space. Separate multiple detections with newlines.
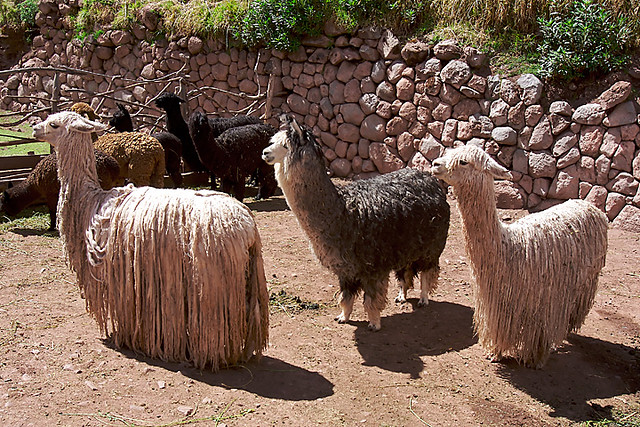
103, 340, 334, 401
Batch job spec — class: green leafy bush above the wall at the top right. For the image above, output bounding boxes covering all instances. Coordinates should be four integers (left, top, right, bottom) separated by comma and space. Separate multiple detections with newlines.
538, 0, 631, 80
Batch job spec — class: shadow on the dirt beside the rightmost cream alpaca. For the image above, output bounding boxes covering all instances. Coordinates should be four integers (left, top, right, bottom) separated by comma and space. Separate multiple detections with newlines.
498, 334, 640, 422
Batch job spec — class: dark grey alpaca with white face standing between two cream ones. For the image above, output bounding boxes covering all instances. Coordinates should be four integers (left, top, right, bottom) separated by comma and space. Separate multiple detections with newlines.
263, 113, 449, 330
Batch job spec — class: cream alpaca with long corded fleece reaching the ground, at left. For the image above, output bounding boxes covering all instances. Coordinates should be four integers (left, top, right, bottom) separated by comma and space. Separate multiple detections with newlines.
34, 112, 269, 370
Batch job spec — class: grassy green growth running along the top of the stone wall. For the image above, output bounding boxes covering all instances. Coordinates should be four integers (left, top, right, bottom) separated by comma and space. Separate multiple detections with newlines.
0, 0, 640, 78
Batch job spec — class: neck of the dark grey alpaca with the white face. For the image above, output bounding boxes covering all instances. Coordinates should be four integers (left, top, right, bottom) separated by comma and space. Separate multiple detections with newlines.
276, 159, 346, 243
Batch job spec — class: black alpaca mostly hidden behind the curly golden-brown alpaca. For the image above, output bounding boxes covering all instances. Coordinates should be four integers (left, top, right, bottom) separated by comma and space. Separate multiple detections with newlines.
109, 103, 183, 188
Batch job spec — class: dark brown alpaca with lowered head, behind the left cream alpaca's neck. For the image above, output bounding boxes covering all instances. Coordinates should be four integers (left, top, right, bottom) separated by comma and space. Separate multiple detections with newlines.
0, 150, 120, 230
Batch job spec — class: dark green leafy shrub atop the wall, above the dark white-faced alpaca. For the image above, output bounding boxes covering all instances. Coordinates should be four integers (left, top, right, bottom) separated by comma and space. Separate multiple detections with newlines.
236, 0, 325, 51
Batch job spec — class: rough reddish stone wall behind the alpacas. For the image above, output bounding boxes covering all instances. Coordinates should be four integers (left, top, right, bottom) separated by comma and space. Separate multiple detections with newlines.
0, 0, 640, 231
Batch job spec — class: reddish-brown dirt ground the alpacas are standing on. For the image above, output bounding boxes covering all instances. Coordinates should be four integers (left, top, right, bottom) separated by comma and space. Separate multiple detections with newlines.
0, 196, 640, 426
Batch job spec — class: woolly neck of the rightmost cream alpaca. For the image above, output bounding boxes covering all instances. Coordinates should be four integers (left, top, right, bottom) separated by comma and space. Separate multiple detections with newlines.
454, 176, 504, 272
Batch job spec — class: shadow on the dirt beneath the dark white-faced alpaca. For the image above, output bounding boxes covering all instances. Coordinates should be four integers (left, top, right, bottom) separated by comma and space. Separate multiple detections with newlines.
352, 299, 477, 378
